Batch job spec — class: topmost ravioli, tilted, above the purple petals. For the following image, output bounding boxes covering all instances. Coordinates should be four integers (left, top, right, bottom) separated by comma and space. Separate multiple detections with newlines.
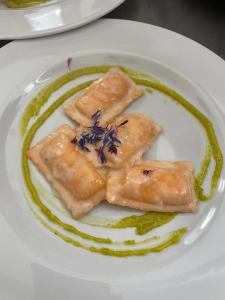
64, 67, 144, 126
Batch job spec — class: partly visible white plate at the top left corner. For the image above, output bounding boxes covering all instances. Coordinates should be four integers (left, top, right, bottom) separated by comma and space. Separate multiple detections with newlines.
0, 0, 125, 40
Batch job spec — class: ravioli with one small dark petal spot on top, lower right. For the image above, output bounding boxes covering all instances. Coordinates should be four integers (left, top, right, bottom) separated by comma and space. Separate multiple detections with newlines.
106, 160, 197, 212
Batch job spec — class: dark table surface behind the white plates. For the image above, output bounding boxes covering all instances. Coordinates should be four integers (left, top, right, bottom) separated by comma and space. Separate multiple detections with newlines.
0, 0, 225, 59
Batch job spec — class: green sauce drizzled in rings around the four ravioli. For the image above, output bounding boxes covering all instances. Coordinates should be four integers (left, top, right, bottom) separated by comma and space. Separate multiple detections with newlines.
21, 65, 223, 256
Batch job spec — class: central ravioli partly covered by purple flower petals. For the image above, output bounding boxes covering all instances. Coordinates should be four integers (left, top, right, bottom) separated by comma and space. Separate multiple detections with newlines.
73, 113, 161, 169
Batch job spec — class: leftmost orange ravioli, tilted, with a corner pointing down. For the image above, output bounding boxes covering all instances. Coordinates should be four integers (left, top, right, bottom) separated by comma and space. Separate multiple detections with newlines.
28, 124, 106, 219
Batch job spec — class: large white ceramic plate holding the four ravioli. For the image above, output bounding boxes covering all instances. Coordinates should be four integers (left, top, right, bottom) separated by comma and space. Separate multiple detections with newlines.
0, 20, 225, 300
